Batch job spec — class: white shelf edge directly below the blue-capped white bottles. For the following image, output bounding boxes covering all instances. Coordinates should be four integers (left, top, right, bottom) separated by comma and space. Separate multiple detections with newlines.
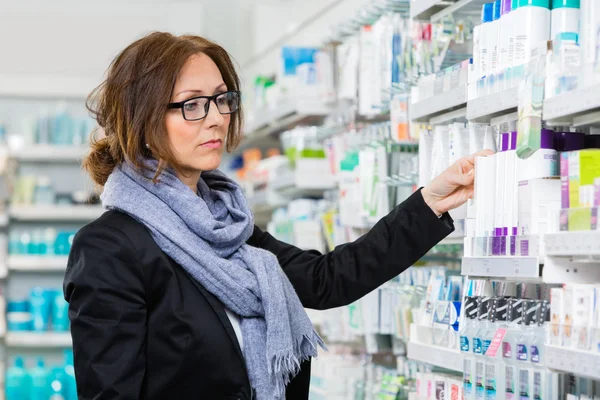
467, 88, 519, 123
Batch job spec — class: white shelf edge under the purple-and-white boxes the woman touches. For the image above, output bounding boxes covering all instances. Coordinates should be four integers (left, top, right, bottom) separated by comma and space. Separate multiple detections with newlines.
462, 256, 541, 280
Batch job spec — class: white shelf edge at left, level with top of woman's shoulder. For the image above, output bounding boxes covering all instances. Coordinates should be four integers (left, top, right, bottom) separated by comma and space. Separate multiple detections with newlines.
9, 205, 105, 222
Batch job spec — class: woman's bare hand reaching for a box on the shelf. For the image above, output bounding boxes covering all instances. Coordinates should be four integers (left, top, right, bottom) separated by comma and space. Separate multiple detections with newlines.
421, 150, 494, 216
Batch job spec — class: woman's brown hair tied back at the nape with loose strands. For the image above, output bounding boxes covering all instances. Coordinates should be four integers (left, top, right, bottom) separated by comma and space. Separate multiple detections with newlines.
83, 32, 243, 186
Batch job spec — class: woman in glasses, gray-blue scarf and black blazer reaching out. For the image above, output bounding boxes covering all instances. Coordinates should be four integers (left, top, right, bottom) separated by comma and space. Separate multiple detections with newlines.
64, 33, 488, 400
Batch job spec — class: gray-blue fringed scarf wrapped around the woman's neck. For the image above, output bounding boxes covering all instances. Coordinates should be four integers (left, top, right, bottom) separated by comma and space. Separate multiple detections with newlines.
102, 161, 323, 400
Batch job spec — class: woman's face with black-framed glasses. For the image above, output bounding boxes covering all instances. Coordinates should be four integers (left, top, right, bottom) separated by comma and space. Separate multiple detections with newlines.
166, 54, 231, 177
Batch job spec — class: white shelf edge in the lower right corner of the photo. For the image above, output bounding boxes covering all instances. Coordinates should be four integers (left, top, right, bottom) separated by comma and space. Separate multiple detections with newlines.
546, 345, 600, 379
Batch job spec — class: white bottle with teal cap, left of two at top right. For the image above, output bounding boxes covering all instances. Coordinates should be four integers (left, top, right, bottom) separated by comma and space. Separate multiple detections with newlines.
514, 0, 550, 66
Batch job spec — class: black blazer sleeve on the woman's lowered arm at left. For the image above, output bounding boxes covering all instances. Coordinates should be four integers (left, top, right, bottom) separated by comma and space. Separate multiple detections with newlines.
63, 225, 146, 400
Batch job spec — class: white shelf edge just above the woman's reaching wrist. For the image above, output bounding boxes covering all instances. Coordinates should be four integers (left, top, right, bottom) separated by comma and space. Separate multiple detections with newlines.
409, 87, 467, 124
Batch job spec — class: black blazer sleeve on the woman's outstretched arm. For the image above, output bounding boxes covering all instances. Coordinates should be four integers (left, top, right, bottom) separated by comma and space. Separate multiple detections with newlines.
248, 190, 454, 310
